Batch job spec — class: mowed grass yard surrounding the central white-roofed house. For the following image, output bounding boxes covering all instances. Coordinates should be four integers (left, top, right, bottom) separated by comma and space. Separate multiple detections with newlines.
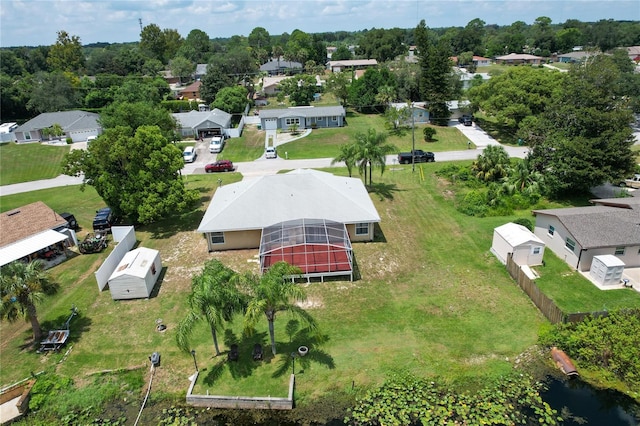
0, 163, 545, 404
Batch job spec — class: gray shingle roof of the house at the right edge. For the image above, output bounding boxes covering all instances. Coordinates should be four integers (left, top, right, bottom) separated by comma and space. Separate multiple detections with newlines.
533, 206, 640, 249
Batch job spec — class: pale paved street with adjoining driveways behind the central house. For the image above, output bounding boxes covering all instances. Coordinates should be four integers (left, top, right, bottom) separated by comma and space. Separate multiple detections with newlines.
0, 124, 528, 196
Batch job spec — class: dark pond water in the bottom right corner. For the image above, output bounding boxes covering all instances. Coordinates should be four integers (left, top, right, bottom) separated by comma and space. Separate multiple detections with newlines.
541, 377, 640, 426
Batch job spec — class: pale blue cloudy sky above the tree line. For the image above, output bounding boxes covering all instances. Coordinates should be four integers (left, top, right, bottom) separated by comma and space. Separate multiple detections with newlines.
0, 0, 640, 47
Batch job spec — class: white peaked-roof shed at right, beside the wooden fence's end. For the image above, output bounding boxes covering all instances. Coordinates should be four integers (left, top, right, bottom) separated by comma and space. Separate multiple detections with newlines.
491, 222, 544, 266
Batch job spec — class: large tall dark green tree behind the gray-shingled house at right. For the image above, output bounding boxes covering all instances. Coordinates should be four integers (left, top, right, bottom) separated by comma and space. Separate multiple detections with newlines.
527, 55, 636, 196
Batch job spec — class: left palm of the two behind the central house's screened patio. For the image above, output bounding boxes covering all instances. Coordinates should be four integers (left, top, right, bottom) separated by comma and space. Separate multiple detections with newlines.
176, 259, 244, 356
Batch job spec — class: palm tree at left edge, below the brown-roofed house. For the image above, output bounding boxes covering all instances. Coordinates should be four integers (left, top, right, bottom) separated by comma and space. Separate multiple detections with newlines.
0, 260, 59, 343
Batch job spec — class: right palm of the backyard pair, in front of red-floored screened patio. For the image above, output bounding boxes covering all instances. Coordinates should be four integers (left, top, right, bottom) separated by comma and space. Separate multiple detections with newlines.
244, 262, 317, 355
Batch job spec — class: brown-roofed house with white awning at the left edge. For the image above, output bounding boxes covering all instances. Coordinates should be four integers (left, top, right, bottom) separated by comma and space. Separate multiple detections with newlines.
0, 201, 75, 267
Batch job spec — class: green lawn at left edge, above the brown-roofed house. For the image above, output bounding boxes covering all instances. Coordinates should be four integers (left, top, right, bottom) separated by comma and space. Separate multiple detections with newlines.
0, 142, 70, 185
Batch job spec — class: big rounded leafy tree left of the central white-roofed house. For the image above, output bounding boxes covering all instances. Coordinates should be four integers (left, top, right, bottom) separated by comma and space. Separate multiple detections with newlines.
63, 125, 197, 224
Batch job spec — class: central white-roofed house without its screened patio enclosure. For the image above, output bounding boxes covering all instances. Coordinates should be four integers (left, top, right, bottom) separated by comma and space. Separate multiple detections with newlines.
198, 169, 380, 251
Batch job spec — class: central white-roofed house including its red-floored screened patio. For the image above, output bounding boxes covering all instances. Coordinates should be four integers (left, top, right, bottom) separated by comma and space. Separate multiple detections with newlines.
198, 169, 380, 282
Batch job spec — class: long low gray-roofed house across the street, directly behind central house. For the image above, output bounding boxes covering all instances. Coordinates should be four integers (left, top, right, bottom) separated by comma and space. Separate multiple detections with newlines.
260, 105, 346, 130
